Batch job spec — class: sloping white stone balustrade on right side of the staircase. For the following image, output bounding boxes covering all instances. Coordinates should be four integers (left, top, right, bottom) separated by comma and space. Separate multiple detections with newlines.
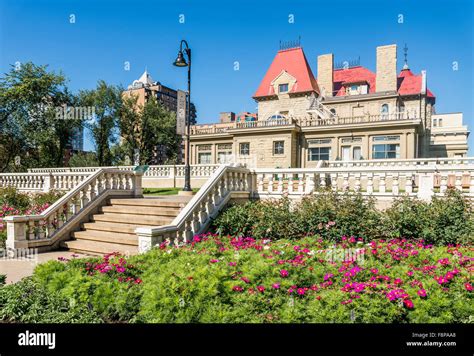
136, 165, 253, 252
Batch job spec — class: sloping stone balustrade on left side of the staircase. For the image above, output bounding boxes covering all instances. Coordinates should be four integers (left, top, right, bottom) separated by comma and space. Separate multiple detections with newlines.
4, 169, 142, 250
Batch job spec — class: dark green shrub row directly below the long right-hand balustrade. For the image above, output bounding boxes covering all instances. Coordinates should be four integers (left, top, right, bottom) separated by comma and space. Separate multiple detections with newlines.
213, 189, 474, 245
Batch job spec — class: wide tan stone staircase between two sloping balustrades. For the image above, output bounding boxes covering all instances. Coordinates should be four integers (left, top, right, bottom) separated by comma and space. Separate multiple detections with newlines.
61, 195, 192, 255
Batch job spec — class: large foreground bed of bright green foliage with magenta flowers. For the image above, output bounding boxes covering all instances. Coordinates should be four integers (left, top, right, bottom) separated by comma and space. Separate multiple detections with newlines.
31, 234, 474, 323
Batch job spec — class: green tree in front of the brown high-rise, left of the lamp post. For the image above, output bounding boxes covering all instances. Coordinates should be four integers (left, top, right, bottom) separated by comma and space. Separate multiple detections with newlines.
119, 96, 179, 164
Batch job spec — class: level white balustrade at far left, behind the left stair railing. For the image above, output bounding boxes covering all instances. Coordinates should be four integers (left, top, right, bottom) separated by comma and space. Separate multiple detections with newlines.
0, 171, 93, 192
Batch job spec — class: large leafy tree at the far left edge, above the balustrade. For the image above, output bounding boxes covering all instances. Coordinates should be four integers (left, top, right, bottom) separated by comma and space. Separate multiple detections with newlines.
0, 62, 80, 172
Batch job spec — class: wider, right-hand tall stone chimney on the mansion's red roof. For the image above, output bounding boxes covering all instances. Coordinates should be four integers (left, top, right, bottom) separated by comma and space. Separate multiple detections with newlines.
375, 44, 397, 92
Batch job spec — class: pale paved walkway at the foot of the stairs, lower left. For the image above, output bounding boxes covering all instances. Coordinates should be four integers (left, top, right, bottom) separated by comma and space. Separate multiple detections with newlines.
0, 251, 90, 284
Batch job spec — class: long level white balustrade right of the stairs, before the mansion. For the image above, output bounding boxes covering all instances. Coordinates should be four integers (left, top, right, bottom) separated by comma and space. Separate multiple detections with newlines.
253, 164, 474, 200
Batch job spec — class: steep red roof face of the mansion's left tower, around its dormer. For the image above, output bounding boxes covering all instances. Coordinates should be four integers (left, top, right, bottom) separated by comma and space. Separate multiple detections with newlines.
253, 47, 319, 98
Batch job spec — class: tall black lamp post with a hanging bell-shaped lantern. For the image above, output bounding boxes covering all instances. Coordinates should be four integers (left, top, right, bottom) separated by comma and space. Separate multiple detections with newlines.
173, 40, 192, 192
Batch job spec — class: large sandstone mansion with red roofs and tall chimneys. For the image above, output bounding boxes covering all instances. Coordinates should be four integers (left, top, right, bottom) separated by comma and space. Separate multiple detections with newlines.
190, 45, 469, 168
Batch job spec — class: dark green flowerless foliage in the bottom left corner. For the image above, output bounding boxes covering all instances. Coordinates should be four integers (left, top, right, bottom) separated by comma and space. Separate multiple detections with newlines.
0, 278, 102, 323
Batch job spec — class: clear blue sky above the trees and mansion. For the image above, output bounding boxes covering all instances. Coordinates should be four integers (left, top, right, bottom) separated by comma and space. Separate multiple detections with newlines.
0, 0, 474, 155
